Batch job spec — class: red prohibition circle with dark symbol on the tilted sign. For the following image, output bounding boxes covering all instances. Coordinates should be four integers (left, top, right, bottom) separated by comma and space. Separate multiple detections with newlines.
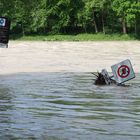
118, 65, 130, 78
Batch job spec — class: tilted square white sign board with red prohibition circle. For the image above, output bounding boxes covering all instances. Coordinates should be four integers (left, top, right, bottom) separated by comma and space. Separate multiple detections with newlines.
111, 59, 135, 84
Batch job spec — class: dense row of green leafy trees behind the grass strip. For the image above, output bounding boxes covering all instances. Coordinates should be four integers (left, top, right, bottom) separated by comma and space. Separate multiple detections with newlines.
0, 0, 140, 35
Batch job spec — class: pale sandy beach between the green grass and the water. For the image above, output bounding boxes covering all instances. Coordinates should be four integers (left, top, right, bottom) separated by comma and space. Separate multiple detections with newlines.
0, 41, 140, 74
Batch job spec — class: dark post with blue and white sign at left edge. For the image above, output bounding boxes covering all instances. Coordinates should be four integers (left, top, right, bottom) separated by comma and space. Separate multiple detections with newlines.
0, 17, 10, 48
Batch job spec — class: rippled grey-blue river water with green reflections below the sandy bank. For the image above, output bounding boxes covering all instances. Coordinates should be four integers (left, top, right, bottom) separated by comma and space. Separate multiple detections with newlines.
0, 73, 140, 140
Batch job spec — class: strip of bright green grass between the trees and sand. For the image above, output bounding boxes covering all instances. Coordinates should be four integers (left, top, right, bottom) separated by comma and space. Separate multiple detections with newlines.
10, 34, 140, 41
